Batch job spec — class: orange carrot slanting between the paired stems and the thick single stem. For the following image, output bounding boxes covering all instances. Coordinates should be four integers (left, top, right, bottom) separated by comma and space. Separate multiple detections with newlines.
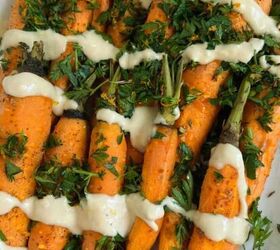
176, 61, 229, 158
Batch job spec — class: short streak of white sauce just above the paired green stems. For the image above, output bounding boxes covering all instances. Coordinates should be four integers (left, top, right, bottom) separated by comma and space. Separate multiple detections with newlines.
119, 49, 163, 69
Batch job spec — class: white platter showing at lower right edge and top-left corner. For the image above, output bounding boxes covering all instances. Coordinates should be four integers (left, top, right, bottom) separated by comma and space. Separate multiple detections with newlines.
0, 0, 280, 250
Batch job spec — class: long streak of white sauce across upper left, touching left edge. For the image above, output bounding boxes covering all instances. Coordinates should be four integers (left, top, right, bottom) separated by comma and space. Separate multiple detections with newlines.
0, 29, 119, 62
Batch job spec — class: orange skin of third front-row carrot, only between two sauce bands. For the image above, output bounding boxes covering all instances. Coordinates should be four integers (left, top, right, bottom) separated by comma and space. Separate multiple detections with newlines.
88, 121, 127, 195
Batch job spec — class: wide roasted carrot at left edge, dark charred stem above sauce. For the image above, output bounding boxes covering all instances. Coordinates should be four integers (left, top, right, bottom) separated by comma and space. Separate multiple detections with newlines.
0, 44, 52, 246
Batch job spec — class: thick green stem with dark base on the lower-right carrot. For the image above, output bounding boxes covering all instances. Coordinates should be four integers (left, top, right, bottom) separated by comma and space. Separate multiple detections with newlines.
220, 77, 251, 147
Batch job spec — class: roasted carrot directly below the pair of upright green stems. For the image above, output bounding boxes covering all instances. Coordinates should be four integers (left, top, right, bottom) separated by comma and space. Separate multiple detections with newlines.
127, 127, 178, 250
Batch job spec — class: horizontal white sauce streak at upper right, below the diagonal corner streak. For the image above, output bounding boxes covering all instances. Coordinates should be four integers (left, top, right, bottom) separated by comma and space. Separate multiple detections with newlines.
182, 38, 264, 64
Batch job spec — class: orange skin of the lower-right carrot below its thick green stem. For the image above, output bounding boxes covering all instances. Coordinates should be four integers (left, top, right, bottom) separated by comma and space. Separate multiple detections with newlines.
188, 165, 240, 250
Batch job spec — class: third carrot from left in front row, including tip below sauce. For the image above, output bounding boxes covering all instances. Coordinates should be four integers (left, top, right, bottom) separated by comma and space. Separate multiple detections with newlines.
82, 121, 127, 250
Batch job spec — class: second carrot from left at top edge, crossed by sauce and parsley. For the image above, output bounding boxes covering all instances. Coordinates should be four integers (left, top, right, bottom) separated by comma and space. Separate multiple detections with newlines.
51, 0, 92, 89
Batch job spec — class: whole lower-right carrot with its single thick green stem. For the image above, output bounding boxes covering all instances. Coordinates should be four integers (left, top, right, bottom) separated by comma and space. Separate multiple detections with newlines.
188, 77, 250, 250
